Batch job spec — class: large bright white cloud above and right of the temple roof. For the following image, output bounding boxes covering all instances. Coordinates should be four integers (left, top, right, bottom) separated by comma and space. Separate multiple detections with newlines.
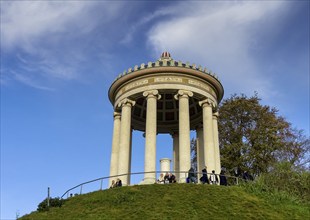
148, 1, 284, 97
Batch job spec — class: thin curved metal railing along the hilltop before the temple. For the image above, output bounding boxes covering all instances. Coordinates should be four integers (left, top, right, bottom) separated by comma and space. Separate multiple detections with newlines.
61, 171, 241, 199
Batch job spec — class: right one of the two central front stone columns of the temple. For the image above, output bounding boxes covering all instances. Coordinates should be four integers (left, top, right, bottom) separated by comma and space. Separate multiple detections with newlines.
175, 90, 193, 183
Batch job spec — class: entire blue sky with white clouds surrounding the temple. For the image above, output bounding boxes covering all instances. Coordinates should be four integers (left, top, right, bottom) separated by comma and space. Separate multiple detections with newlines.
0, 1, 310, 219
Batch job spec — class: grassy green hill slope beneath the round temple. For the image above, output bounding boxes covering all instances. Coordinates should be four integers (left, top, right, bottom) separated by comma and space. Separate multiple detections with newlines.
20, 184, 310, 220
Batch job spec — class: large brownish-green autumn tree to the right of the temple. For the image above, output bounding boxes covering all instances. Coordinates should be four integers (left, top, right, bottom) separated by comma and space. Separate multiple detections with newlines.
218, 94, 309, 175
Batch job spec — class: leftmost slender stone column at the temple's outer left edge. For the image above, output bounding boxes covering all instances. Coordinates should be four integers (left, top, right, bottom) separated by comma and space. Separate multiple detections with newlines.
109, 112, 121, 186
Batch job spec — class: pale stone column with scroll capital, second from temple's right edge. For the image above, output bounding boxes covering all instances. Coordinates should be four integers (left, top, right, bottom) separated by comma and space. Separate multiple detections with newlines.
199, 98, 215, 173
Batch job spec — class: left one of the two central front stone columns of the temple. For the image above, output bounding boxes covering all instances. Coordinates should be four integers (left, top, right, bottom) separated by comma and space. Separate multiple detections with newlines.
142, 90, 161, 184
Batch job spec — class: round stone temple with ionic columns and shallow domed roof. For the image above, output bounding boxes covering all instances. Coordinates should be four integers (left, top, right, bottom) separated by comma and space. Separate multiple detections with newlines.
109, 52, 224, 185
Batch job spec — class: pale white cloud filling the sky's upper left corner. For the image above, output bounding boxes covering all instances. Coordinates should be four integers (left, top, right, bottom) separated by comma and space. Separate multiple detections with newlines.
1, 1, 119, 49
